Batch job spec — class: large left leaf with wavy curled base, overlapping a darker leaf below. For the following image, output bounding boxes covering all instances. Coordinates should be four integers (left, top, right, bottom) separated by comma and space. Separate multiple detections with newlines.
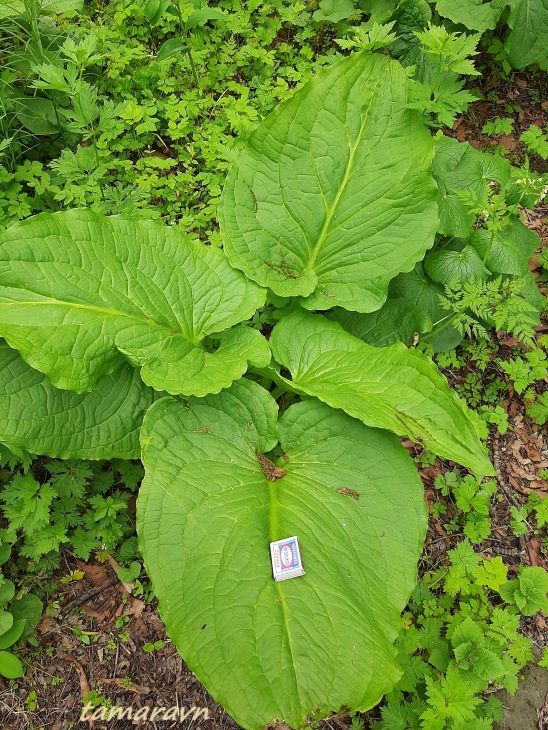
0, 210, 270, 395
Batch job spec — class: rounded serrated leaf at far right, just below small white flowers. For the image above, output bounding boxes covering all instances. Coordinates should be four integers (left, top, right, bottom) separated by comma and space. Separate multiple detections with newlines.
470, 216, 541, 276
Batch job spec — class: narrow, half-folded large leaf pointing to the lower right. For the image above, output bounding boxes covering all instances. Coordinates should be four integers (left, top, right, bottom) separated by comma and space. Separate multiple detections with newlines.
270, 312, 494, 476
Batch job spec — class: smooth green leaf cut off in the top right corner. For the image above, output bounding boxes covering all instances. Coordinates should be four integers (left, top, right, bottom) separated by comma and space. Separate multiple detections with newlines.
504, 0, 548, 68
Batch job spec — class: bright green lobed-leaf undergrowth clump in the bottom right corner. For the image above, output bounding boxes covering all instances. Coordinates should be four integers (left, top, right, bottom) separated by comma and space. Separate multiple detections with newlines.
373, 540, 548, 730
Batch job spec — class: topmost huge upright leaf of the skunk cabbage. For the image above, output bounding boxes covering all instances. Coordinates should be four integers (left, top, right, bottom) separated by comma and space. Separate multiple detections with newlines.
219, 53, 437, 312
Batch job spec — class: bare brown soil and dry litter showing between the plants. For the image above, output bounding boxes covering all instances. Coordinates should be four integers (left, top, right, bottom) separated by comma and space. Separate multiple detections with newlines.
0, 62, 548, 730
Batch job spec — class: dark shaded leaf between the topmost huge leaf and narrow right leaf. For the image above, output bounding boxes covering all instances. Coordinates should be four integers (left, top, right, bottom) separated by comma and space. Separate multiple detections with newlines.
326, 299, 432, 347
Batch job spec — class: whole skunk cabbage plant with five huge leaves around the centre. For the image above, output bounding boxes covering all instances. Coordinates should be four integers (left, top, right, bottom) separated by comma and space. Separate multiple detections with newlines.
0, 53, 493, 730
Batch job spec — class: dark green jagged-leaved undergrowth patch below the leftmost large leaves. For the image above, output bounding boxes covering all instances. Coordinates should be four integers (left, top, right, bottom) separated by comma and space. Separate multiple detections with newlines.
0, 459, 142, 568
